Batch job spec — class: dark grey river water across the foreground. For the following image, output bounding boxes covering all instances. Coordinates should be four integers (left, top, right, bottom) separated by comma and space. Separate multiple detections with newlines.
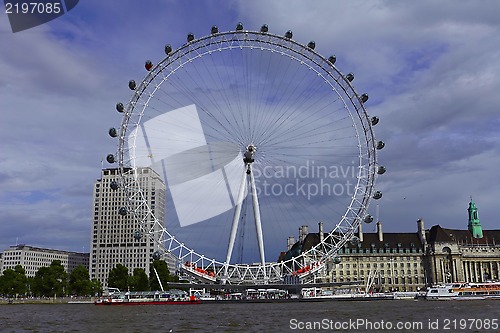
0, 300, 500, 333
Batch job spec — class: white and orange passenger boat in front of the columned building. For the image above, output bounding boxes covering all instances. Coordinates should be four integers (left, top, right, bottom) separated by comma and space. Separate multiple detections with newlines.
425, 282, 500, 300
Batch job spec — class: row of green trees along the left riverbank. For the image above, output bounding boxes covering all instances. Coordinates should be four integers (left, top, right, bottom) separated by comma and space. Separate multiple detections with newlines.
0, 260, 178, 297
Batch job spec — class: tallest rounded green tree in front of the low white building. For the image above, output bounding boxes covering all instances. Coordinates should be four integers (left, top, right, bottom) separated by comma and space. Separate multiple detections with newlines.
31, 260, 68, 296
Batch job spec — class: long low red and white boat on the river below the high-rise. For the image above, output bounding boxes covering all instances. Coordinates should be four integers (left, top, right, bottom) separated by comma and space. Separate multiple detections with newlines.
94, 289, 201, 305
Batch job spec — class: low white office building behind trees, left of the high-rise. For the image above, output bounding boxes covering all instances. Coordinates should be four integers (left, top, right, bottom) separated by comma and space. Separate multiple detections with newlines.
1, 244, 89, 277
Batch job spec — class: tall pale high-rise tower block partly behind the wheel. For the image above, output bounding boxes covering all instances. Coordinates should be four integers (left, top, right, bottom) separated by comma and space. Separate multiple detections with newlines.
89, 168, 173, 287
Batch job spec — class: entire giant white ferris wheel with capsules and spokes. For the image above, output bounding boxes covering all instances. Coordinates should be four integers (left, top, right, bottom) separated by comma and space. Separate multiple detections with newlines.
108, 23, 385, 284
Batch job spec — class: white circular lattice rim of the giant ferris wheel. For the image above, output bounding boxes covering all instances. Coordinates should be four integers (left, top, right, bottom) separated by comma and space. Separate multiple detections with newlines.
114, 25, 377, 282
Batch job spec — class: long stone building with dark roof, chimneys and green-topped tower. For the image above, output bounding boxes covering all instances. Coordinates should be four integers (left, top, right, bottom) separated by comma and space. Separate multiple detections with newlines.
281, 199, 500, 291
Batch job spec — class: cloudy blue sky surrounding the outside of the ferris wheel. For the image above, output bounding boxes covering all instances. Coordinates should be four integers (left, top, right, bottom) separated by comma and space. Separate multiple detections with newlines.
0, 0, 500, 252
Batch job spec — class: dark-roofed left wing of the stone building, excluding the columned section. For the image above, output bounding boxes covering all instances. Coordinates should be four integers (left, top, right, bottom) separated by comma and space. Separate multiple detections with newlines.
282, 220, 427, 292
